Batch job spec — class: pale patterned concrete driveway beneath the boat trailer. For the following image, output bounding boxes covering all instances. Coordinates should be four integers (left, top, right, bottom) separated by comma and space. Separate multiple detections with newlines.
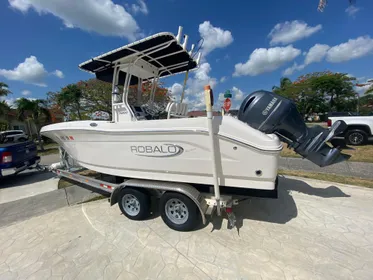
0, 178, 373, 280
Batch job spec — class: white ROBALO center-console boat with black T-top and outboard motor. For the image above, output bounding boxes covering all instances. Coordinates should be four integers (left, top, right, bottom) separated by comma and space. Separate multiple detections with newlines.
41, 28, 348, 195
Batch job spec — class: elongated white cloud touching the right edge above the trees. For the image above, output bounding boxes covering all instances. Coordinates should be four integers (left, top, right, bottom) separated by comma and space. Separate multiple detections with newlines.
326, 36, 373, 63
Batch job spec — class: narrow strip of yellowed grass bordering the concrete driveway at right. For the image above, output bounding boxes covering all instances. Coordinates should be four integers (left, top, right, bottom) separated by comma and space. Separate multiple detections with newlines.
278, 170, 373, 188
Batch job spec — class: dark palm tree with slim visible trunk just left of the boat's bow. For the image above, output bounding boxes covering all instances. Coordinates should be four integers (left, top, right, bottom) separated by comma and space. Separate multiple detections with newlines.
16, 98, 51, 151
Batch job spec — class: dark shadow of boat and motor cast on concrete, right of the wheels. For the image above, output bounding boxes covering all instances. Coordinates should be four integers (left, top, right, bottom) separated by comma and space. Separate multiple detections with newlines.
206, 177, 350, 231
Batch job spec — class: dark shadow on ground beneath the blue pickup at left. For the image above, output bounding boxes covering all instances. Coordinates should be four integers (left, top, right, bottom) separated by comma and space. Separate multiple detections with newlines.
0, 171, 55, 189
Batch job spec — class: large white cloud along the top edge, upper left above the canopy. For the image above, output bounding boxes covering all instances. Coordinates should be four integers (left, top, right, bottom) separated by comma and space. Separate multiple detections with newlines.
8, 0, 139, 40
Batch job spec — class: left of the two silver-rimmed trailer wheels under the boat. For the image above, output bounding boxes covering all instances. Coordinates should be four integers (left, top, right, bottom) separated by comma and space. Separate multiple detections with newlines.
118, 187, 150, 221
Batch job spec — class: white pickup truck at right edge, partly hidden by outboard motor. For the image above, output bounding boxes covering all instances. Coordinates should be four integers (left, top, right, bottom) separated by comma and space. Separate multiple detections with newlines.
327, 116, 373, 146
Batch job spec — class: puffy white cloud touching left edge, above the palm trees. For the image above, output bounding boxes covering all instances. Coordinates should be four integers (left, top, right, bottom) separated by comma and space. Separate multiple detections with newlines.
0, 55, 48, 87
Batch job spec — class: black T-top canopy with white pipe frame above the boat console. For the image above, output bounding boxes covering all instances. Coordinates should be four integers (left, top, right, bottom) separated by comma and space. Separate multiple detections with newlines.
79, 32, 198, 85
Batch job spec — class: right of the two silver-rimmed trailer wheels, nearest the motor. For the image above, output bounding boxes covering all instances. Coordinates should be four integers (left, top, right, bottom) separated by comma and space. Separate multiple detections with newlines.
160, 192, 200, 231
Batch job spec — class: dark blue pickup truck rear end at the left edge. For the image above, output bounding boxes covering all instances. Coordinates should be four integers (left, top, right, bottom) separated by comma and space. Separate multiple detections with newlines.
0, 139, 40, 177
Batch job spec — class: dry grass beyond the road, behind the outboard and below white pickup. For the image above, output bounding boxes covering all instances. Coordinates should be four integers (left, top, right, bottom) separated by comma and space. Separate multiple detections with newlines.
281, 143, 373, 163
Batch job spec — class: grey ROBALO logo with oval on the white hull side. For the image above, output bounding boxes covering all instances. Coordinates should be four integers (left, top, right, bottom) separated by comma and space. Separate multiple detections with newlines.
131, 144, 184, 157
